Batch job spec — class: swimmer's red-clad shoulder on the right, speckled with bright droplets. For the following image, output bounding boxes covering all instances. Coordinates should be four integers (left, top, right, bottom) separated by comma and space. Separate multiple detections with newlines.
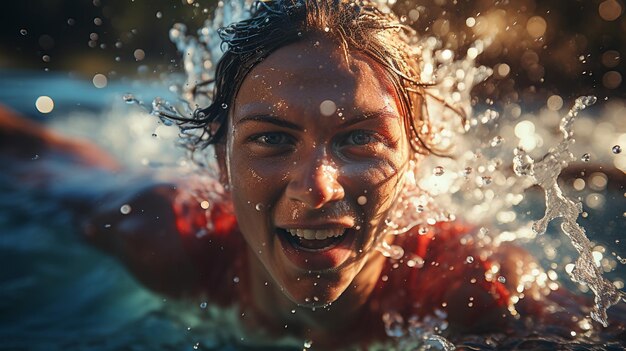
382, 222, 541, 332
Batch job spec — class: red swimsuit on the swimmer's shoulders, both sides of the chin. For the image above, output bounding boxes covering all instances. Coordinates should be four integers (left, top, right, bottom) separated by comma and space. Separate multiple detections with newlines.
176, 199, 511, 340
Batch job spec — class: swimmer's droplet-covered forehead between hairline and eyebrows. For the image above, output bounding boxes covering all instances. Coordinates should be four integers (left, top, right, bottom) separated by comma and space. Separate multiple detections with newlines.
234, 37, 399, 118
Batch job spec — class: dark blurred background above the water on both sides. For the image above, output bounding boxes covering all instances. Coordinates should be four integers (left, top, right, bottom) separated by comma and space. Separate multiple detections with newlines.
0, 0, 626, 107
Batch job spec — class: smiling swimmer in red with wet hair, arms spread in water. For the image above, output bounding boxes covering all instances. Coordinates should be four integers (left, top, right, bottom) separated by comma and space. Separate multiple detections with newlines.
0, 0, 620, 350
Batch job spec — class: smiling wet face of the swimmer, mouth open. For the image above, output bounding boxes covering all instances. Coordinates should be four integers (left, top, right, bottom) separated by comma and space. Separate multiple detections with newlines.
218, 38, 410, 306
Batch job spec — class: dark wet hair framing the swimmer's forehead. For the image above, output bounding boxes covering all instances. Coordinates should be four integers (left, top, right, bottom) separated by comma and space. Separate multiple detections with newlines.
173, 0, 450, 153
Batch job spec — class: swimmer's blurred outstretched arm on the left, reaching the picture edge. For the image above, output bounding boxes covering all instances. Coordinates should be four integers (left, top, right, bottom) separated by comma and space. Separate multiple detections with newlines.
0, 106, 234, 295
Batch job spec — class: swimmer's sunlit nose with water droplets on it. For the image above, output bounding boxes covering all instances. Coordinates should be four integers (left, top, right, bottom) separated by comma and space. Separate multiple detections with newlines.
286, 154, 345, 209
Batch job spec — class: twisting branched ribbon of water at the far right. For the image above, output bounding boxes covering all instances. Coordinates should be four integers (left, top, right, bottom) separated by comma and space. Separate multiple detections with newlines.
513, 96, 624, 327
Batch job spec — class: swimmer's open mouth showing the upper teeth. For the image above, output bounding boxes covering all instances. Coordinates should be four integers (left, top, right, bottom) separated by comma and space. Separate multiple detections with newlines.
276, 228, 355, 270
